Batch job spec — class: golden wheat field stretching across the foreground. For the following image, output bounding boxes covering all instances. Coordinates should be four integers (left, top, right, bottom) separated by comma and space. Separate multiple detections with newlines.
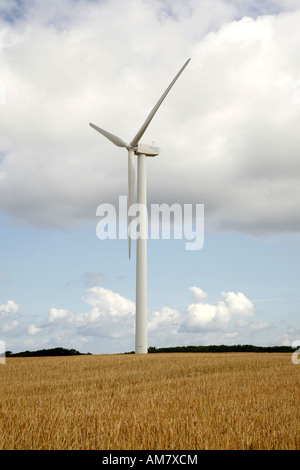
0, 353, 300, 450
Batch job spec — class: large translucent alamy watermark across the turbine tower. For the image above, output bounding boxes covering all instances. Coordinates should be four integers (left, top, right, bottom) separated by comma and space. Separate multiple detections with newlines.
96, 196, 204, 250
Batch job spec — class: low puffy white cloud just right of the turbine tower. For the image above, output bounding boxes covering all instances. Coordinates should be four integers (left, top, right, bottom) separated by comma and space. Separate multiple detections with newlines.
149, 286, 270, 346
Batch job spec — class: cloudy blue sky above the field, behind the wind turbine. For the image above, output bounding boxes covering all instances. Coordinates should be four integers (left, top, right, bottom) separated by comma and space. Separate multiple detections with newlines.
0, 0, 300, 354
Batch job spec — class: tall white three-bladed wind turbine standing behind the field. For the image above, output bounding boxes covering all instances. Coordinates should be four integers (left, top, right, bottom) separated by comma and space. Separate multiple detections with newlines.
90, 59, 191, 354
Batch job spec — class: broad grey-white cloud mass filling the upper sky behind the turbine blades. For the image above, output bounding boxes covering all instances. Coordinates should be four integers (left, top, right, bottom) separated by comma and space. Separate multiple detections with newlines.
0, 0, 300, 233
